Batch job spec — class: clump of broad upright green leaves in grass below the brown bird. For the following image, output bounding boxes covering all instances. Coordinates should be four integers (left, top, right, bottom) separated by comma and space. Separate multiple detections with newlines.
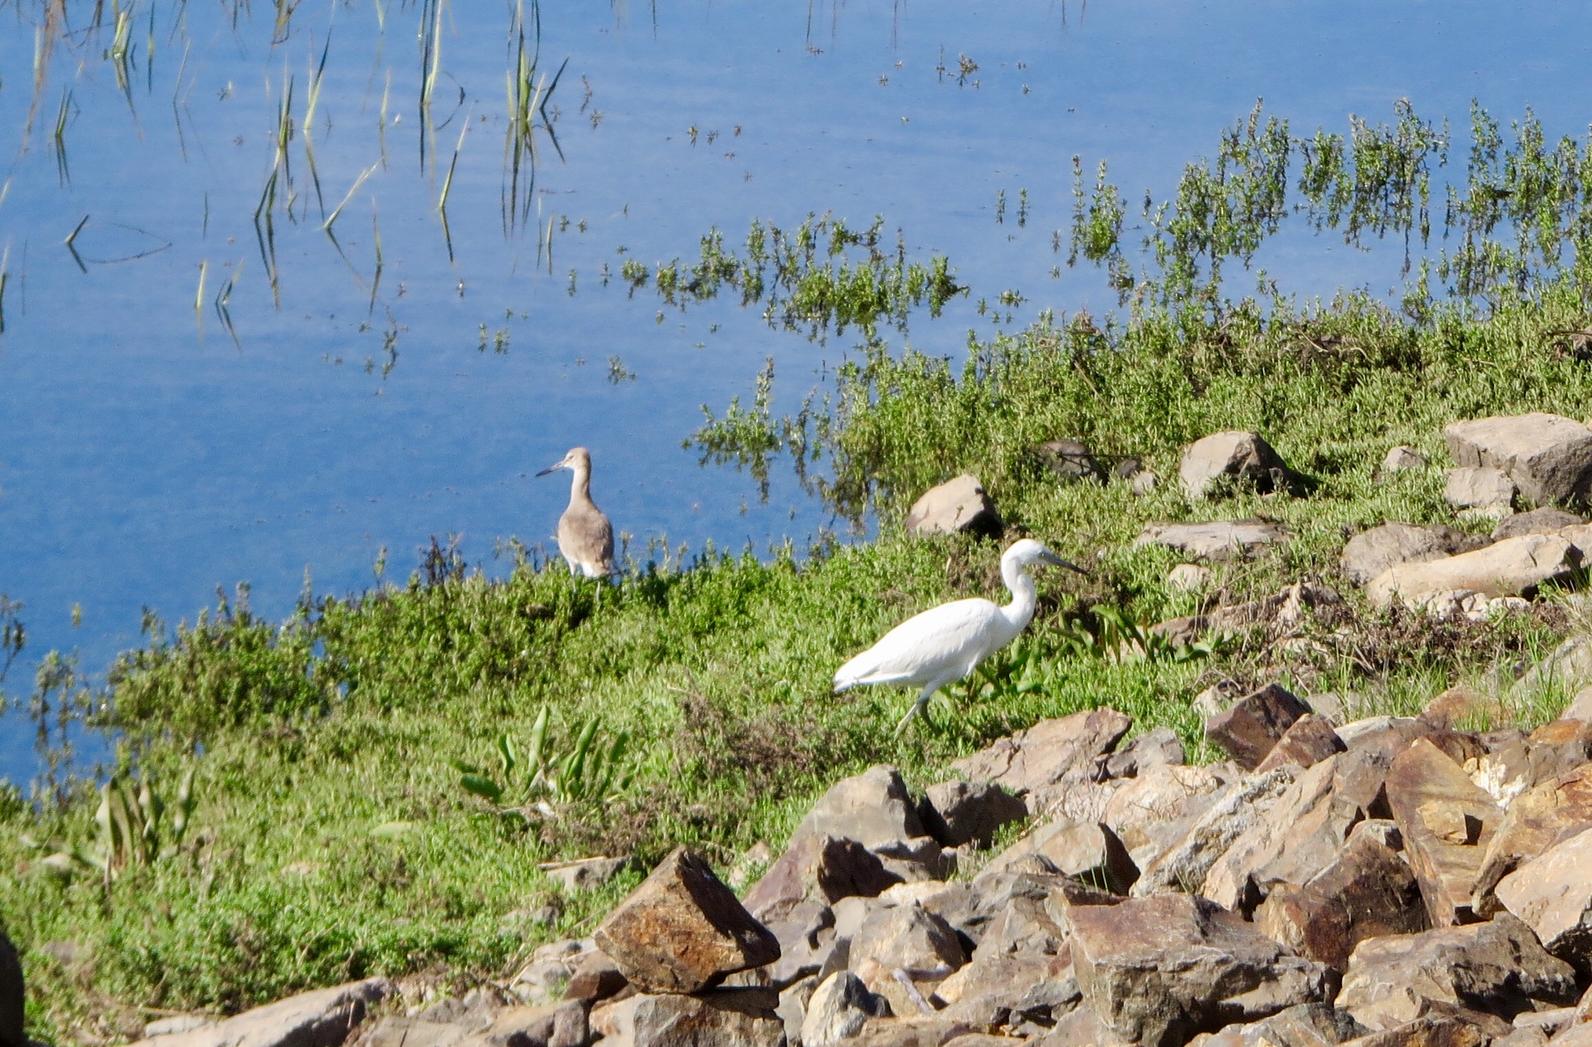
452, 705, 635, 821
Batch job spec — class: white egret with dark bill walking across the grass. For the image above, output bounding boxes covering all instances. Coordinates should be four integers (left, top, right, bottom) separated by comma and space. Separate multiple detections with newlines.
834, 538, 1089, 734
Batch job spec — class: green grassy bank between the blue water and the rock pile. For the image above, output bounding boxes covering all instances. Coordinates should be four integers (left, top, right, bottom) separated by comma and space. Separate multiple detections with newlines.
0, 280, 1592, 1042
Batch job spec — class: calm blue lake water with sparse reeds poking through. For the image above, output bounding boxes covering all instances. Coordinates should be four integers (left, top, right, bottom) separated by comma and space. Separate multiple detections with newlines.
0, 0, 1592, 783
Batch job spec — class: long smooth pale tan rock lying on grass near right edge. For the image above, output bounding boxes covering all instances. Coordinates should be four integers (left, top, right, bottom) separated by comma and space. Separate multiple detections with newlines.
1366, 535, 1581, 608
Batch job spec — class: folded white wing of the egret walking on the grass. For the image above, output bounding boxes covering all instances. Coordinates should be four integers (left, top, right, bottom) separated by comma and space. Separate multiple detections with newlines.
834, 597, 1000, 691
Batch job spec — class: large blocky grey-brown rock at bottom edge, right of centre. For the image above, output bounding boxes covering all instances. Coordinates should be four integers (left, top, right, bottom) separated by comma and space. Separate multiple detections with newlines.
1070, 894, 1336, 1044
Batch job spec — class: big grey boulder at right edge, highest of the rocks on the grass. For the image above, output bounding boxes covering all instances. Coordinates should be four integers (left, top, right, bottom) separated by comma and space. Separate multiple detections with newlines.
1442, 412, 1592, 504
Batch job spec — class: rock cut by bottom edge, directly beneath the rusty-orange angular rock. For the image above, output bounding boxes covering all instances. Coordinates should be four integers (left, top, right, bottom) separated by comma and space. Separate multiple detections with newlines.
591, 988, 785, 1047
